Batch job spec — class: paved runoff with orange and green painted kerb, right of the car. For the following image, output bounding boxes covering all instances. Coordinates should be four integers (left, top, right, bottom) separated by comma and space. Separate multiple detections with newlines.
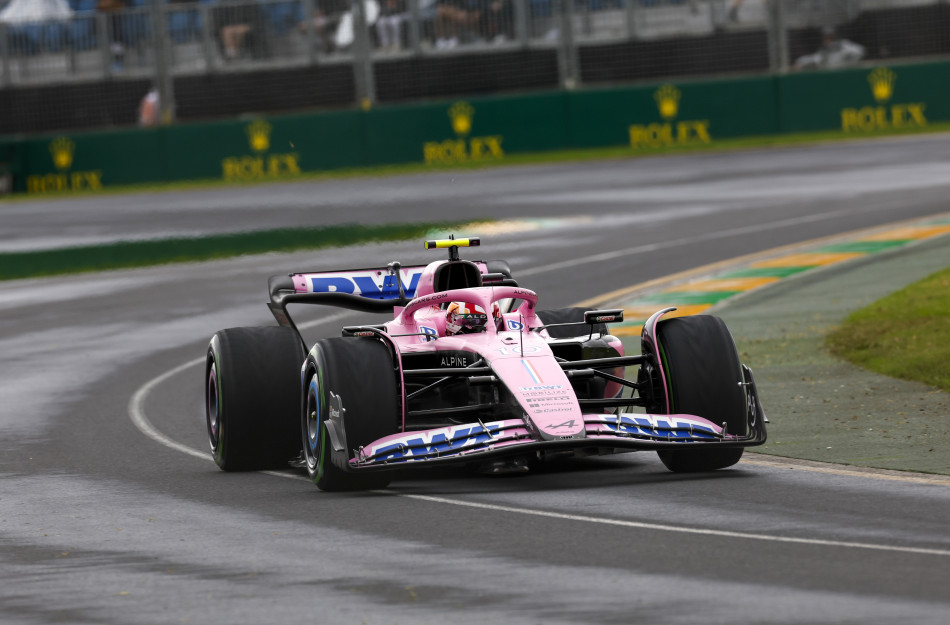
596, 215, 950, 475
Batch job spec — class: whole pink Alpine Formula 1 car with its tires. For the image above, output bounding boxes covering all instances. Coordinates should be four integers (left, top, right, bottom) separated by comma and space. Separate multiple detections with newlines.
205, 238, 766, 490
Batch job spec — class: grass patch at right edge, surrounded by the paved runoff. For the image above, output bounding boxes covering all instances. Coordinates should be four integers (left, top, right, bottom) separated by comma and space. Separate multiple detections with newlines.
827, 268, 950, 391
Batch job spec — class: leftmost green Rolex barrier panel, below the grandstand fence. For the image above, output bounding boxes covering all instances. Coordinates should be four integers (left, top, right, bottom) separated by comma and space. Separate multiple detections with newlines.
14, 129, 167, 193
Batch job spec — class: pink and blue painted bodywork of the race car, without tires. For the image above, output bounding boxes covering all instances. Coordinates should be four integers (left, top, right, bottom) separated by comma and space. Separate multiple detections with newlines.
292, 261, 731, 468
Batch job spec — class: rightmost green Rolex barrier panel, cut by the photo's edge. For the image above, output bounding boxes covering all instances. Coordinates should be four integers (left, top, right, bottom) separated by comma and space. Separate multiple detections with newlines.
778, 62, 950, 134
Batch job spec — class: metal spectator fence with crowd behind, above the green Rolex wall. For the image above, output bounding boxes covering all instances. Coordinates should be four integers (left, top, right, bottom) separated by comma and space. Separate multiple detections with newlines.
0, 0, 950, 133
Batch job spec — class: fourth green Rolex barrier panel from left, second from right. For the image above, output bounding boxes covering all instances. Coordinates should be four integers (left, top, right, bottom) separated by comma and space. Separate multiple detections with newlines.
568, 76, 779, 149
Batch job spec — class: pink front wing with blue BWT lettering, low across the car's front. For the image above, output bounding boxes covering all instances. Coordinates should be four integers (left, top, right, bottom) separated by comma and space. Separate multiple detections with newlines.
349, 408, 766, 471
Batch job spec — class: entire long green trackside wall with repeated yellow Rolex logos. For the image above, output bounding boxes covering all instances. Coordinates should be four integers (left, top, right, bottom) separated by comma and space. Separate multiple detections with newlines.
0, 61, 950, 194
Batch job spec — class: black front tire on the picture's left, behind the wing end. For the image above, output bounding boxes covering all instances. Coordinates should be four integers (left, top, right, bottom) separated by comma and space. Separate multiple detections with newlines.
300, 338, 402, 491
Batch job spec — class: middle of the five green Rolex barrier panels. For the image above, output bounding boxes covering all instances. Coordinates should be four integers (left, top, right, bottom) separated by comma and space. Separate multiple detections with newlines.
363, 92, 568, 165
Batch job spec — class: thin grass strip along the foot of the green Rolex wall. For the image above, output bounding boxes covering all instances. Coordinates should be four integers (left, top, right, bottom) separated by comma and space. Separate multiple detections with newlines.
7, 122, 950, 204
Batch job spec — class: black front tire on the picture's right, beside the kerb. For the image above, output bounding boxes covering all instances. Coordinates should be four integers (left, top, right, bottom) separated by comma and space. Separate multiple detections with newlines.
657, 315, 749, 473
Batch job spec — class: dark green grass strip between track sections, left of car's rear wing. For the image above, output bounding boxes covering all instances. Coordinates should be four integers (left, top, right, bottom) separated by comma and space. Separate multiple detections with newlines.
0, 223, 461, 280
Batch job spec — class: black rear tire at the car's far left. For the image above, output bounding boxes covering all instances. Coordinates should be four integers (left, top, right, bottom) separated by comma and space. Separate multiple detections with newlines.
205, 326, 306, 471
